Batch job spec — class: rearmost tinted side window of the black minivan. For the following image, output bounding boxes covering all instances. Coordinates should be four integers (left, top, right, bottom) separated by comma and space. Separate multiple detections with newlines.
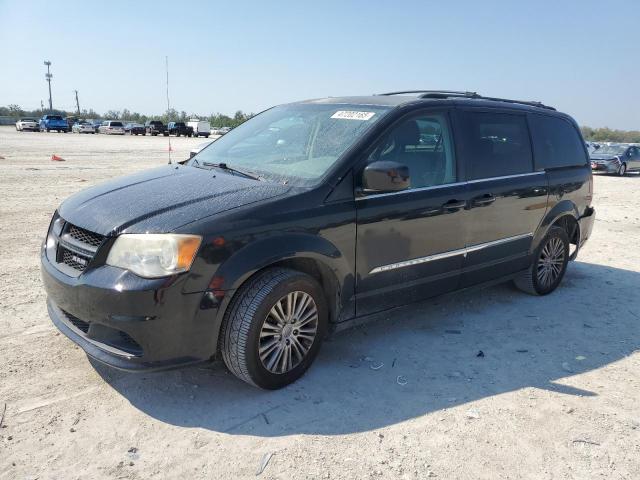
529, 115, 587, 170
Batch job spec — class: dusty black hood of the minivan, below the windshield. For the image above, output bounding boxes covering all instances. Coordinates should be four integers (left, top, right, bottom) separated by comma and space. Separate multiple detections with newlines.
58, 165, 291, 235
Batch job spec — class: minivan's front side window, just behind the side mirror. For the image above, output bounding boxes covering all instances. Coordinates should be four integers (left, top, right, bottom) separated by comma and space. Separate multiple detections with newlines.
369, 114, 456, 188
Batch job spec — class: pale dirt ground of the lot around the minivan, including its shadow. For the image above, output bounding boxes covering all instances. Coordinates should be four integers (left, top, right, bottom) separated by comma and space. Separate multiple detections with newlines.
0, 127, 640, 480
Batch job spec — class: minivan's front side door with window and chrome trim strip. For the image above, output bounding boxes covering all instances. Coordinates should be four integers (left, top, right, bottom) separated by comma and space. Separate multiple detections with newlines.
356, 110, 468, 315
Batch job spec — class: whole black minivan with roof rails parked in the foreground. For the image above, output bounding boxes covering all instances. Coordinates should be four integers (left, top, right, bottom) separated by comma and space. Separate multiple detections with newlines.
42, 91, 594, 389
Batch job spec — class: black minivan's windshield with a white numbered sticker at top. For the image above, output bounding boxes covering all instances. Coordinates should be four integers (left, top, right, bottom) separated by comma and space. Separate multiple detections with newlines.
189, 104, 389, 185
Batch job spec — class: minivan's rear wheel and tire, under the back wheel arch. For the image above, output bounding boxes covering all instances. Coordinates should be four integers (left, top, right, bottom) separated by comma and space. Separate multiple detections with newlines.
513, 227, 569, 295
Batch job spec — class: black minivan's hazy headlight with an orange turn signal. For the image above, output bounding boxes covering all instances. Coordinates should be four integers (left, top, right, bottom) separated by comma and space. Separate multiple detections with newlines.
107, 233, 202, 278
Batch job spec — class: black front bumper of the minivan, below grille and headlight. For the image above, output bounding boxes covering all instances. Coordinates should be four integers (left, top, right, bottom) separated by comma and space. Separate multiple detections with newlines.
41, 252, 220, 371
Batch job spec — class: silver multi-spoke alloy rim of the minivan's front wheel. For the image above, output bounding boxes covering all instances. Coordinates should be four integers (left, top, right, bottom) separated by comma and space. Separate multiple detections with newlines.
258, 291, 318, 374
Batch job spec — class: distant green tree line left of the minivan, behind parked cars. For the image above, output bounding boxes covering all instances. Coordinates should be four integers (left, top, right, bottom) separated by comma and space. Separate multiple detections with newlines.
0, 104, 254, 128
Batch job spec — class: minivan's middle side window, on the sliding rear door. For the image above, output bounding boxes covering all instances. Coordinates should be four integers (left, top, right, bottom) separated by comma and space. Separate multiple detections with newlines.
461, 112, 533, 180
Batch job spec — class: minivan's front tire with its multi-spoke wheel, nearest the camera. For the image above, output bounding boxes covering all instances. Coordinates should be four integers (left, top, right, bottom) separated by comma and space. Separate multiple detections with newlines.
219, 268, 328, 390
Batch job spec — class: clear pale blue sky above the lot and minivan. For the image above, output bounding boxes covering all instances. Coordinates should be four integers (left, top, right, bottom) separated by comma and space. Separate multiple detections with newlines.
0, 0, 640, 130
